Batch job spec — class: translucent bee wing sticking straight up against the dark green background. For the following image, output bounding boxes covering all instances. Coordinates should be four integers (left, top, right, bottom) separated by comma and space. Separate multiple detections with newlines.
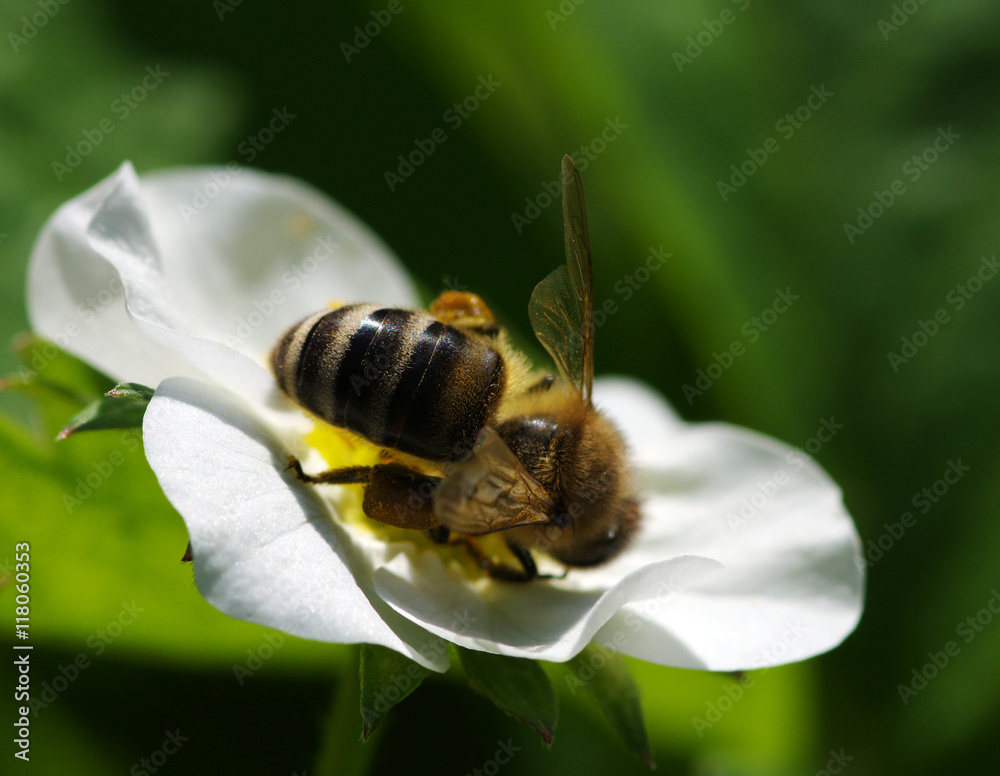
528, 156, 594, 402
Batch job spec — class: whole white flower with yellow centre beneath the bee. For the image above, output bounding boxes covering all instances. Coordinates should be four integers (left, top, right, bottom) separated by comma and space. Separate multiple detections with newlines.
28, 164, 864, 671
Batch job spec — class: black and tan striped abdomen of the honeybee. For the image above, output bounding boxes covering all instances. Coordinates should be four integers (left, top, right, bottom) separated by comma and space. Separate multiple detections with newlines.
271, 304, 506, 461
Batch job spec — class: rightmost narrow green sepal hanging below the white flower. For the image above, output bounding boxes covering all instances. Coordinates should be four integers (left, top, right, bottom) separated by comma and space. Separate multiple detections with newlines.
564, 642, 656, 769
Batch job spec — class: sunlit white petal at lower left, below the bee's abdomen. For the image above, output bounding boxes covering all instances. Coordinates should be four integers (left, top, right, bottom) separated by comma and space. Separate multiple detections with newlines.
143, 378, 448, 671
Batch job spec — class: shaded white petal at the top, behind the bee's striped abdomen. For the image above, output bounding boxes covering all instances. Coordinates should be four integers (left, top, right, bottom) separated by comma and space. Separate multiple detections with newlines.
142, 167, 417, 358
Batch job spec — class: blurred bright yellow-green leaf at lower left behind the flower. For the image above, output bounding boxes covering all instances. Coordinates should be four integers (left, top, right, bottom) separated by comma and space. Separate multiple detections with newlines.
0, 386, 357, 668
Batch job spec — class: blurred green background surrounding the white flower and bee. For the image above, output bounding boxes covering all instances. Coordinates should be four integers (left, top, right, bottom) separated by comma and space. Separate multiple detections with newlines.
0, 0, 1000, 776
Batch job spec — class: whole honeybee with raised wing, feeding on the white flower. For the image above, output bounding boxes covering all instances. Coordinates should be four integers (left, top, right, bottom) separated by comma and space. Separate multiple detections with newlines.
271, 156, 640, 581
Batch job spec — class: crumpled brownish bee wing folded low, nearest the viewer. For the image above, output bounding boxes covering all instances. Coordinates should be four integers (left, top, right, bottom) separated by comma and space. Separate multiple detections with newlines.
434, 427, 555, 536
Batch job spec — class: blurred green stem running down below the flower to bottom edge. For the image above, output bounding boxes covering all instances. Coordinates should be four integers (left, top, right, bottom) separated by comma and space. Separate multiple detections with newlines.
316, 647, 375, 776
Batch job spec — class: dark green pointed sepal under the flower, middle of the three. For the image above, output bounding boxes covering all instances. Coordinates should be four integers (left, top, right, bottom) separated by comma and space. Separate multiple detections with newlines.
458, 647, 559, 744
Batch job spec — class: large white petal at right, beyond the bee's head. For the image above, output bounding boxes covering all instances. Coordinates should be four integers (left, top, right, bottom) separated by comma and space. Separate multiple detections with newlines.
595, 381, 864, 671
